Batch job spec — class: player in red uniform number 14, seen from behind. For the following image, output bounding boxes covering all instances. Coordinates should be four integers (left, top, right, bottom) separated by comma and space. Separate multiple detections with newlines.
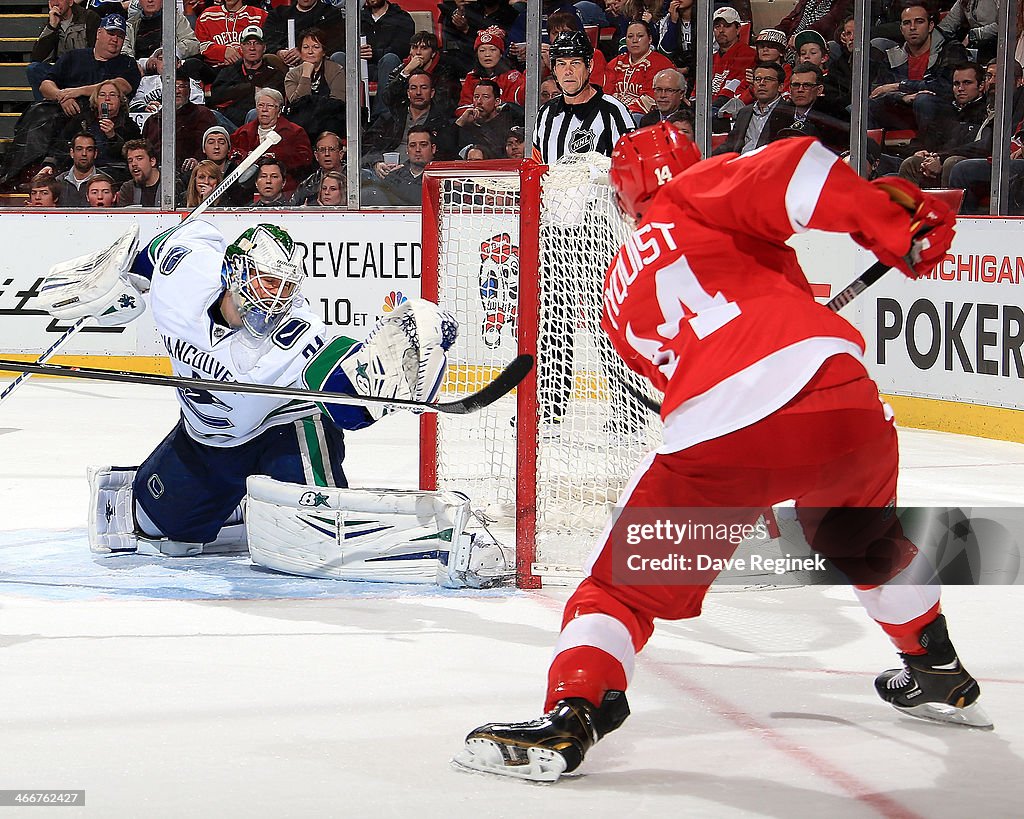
455, 123, 991, 781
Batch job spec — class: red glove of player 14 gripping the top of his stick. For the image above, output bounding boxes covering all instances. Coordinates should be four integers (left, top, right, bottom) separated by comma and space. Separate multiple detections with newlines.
853, 176, 956, 278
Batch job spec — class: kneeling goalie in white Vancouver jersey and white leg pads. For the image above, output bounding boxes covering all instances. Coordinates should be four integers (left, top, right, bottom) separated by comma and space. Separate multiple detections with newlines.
41, 220, 513, 587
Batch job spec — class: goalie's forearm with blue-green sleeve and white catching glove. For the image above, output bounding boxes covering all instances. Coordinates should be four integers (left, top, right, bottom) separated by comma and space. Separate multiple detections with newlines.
302, 299, 459, 421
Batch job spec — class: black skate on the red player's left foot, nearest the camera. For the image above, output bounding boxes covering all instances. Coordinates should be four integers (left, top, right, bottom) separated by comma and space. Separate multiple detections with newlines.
452, 691, 630, 782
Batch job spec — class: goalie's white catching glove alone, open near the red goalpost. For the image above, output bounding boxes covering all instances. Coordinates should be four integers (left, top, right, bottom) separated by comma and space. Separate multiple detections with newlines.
338, 299, 459, 418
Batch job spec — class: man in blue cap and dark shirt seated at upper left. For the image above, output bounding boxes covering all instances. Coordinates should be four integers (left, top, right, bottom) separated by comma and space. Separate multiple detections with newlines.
39, 13, 142, 117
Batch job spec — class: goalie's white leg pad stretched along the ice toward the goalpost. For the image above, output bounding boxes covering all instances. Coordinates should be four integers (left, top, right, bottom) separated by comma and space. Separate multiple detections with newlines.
246, 475, 516, 587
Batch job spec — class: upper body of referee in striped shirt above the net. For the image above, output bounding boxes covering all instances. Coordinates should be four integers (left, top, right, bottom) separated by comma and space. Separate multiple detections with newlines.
534, 31, 634, 165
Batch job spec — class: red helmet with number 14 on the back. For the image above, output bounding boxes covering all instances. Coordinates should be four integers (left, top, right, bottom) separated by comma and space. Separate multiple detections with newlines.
608, 122, 700, 221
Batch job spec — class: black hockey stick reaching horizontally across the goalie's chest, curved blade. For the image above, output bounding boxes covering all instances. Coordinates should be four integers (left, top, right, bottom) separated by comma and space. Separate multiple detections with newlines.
0, 355, 534, 416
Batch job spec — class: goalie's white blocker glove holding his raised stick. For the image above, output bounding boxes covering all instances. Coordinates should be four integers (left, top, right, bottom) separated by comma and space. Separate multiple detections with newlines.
39, 226, 150, 327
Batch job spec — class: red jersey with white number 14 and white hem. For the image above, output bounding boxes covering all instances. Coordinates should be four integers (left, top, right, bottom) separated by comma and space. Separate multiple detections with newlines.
602, 138, 910, 451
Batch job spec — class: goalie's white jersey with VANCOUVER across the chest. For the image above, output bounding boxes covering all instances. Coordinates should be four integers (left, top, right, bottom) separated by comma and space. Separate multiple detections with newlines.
148, 220, 325, 446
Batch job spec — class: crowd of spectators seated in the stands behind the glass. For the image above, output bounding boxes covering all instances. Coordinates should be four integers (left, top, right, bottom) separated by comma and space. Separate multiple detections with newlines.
6, 0, 1024, 212
